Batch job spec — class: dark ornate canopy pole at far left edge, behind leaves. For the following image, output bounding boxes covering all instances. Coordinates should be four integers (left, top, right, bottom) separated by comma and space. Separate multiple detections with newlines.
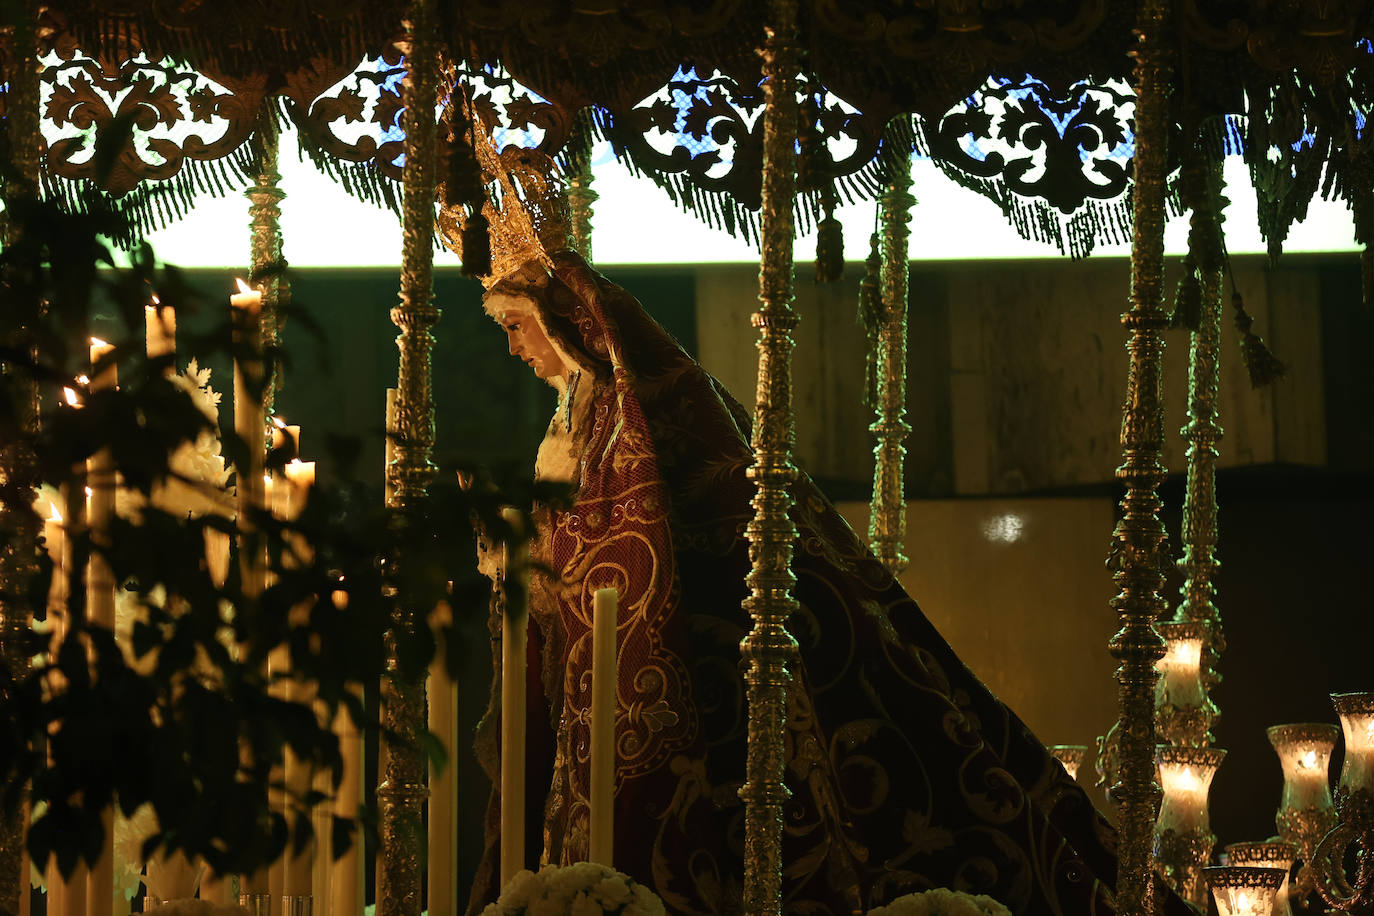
0, 3, 41, 916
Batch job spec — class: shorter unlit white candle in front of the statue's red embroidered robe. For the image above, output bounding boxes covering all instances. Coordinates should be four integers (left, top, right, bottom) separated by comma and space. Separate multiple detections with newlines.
588, 588, 620, 867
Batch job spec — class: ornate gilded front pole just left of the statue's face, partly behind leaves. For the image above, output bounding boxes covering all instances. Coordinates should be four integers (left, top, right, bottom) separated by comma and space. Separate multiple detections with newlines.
376, 0, 438, 916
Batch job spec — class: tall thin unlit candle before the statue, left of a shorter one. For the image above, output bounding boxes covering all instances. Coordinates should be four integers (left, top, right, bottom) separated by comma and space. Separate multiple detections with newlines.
502, 508, 529, 887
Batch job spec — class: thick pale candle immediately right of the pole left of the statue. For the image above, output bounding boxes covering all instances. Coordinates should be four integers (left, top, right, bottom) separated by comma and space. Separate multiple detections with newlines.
427, 602, 458, 916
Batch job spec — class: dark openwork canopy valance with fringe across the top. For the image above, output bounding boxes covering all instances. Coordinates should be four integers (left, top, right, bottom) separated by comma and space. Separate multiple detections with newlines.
4, 0, 1374, 254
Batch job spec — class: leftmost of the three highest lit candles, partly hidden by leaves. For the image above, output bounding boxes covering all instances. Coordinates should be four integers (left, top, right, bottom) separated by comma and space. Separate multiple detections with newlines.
85, 338, 120, 916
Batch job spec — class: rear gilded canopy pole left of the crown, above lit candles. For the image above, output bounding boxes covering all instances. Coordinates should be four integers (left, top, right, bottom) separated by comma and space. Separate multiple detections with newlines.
243, 114, 291, 416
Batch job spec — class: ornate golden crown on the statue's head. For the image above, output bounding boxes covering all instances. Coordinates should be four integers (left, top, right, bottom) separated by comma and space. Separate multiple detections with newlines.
438, 100, 572, 290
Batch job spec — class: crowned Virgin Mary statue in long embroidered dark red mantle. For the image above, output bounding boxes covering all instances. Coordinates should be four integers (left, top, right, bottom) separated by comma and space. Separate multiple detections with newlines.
440, 143, 1154, 916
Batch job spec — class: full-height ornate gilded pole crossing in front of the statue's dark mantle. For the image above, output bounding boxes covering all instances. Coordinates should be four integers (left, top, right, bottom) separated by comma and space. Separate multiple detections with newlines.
739, 0, 798, 916
